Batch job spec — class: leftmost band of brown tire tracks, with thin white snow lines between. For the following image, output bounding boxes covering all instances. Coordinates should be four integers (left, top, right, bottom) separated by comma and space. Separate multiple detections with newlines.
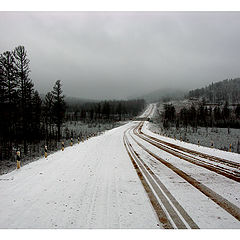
124, 127, 199, 229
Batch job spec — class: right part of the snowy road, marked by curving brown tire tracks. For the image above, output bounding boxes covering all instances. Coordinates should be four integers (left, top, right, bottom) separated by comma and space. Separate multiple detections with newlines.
125, 104, 240, 228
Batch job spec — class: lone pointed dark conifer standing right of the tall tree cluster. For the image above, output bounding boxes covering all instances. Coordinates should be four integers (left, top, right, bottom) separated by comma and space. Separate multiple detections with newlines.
52, 80, 66, 141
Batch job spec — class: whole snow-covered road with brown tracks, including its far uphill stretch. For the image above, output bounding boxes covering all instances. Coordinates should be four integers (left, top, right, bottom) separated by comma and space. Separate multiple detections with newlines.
0, 105, 240, 228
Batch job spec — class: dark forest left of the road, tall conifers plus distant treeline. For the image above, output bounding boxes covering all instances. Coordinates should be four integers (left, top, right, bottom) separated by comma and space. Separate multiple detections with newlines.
0, 46, 145, 167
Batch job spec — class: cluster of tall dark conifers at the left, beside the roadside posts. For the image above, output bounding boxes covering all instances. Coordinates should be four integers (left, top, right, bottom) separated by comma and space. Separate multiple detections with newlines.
0, 46, 65, 159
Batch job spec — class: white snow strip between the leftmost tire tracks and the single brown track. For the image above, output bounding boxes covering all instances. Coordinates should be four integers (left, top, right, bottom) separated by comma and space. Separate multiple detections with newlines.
127, 135, 240, 229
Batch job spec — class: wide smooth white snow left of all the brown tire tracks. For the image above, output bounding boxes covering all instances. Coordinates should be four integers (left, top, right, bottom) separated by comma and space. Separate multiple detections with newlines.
0, 124, 159, 228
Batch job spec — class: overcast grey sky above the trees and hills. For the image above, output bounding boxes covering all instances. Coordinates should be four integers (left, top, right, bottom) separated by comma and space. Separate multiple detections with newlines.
0, 12, 240, 99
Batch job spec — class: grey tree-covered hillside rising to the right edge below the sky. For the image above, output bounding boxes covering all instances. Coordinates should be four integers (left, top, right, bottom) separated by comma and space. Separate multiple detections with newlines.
188, 78, 240, 103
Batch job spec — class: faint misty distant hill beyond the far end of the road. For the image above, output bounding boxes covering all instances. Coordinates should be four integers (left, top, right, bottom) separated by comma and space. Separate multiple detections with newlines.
132, 88, 187, 102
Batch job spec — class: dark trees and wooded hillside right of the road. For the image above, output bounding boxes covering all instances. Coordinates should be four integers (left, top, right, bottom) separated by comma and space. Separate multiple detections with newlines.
159, 78, 240, 129
